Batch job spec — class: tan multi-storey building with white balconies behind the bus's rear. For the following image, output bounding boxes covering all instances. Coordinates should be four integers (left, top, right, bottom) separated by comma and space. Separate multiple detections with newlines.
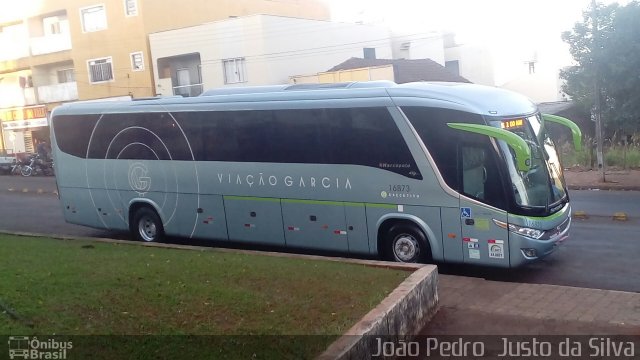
0, 0, 330, 152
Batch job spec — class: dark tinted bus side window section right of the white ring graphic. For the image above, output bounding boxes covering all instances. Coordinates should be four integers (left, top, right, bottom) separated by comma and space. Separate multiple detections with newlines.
178, 108, 422, 179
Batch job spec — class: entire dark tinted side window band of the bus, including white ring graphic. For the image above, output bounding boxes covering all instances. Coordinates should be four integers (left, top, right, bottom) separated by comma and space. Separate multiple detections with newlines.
54, 107, 422, 179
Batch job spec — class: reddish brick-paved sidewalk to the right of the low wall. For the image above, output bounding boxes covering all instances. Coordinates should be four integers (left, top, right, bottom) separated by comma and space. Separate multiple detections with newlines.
420, 275, 640, 336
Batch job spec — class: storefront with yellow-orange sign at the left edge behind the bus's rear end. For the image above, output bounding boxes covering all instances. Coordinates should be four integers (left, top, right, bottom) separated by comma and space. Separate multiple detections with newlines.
0, 105, 50, 153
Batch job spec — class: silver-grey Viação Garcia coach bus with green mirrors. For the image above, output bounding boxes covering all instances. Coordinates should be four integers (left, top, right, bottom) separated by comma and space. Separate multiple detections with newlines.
51, 81, 581, 267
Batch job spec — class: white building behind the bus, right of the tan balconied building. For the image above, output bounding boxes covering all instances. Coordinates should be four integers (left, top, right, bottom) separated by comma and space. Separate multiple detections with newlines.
149, 15, 392, 96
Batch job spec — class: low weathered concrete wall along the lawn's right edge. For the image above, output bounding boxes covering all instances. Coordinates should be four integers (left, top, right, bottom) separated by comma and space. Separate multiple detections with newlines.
317, 265, 438, 360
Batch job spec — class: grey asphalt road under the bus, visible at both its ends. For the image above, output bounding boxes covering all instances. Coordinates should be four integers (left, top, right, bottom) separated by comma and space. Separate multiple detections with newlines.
0, 176, 640, 292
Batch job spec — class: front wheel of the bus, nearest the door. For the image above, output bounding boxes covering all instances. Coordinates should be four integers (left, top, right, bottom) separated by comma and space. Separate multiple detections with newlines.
384, 223, 431, 263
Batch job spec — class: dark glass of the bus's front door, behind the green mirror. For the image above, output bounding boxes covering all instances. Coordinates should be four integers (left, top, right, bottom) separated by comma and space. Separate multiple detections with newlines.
459, 144, 505, 209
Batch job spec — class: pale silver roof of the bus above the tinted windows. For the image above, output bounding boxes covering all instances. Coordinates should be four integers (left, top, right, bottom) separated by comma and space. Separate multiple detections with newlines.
55, 81, 537, 116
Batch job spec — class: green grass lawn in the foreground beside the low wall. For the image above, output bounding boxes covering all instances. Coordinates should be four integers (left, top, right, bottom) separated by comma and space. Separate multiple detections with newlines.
0, 235, 409, 358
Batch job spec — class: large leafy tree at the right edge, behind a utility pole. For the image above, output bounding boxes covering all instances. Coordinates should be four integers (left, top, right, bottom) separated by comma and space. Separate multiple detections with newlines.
560, 1, 640, 137
